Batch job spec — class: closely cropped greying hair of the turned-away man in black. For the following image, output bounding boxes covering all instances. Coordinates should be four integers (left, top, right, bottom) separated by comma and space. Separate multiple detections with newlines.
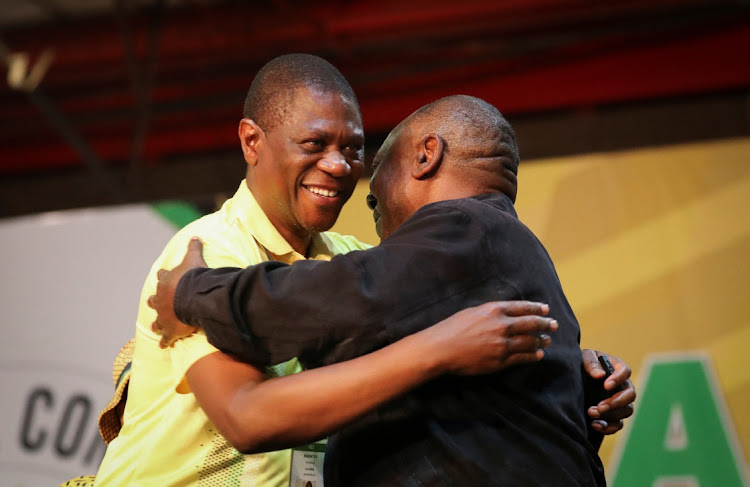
394, 95, 520, 201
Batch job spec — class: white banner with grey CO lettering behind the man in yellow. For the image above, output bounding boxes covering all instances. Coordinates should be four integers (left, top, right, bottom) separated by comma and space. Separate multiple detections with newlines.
0, 205, 181, 487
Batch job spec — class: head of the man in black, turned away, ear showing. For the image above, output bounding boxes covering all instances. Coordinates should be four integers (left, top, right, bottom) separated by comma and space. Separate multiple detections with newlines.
367, 95, 519, 238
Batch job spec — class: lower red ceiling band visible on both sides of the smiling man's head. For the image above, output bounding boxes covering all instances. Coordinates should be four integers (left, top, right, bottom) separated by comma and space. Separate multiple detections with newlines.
0, 21, 750, 172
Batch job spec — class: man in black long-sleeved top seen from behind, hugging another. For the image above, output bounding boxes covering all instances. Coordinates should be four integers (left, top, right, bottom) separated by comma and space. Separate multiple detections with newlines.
152, 96, 636, 487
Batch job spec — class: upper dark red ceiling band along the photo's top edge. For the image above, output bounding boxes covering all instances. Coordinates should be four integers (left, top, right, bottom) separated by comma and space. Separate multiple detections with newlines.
5, 0, 722, 85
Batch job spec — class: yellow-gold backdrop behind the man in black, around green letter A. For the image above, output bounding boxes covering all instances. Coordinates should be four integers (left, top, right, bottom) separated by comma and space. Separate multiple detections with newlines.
334, 138, 750, 476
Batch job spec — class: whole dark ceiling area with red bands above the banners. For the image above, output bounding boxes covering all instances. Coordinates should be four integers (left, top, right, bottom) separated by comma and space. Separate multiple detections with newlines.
0, 0, 750, 217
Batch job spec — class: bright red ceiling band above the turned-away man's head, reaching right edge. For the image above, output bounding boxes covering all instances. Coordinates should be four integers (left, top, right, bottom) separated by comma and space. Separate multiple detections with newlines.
361, 25, 750, 131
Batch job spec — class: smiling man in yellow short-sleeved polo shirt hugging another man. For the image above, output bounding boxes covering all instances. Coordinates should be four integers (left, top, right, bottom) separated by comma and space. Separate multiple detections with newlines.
96, 55, 568, 486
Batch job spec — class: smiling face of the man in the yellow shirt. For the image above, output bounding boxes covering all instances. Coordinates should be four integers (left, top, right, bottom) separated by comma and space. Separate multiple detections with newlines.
248, 87, 364, 253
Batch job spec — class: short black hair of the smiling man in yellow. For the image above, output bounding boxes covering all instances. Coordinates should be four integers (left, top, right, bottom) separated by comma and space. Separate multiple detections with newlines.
242, 53, 359, 131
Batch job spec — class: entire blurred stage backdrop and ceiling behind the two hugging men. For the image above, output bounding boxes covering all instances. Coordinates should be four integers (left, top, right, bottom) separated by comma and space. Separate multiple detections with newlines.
0, 0, 750, 487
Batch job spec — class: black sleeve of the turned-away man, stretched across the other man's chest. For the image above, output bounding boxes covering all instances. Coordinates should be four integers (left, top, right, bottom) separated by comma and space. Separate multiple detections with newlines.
175, 203, 496, 366
